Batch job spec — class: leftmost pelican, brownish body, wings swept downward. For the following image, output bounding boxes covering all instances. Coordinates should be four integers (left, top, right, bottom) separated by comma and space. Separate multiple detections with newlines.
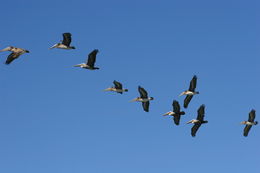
0, 46, 29, 65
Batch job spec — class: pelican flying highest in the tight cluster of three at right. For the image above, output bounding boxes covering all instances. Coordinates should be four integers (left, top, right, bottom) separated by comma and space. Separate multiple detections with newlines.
179, 75, 199, 108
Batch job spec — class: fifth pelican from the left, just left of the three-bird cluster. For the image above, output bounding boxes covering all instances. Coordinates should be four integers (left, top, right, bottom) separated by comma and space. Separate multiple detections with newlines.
131, 86, 154, 112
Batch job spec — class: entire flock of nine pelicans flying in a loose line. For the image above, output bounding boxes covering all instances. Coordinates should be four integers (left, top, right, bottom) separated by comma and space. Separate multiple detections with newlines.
0, 33, 258, 137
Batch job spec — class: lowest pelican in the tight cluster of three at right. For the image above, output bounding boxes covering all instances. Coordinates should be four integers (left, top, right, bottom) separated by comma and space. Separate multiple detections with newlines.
187, 105, 208, 137
